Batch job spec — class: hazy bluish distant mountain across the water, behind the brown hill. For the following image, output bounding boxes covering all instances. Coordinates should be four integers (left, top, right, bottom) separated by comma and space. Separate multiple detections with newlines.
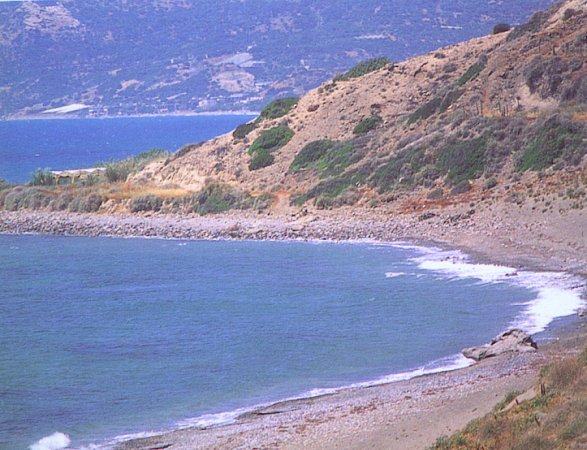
0, 0, 552, 117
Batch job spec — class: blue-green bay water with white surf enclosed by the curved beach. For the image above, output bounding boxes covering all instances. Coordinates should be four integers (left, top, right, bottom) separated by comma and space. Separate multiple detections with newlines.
0, 235, 581, 449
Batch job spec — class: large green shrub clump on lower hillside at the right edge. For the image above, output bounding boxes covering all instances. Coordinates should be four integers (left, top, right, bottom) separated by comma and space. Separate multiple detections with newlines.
517, 116, 587, 171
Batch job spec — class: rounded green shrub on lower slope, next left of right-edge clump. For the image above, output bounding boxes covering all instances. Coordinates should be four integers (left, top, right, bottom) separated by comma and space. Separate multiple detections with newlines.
437, 137, 487, 186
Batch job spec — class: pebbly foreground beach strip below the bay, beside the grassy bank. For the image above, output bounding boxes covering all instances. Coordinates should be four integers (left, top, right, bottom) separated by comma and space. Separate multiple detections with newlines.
111, 317, 587, 450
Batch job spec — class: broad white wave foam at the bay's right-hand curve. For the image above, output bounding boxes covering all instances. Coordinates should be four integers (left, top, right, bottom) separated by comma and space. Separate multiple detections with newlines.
404, 243, 584, 334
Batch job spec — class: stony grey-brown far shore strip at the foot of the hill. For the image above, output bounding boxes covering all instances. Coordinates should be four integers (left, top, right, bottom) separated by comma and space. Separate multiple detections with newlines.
0, 208, 587, 278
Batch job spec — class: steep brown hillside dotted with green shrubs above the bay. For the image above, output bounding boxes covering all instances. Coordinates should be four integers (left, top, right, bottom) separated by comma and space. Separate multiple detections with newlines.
134, 0, 587, 216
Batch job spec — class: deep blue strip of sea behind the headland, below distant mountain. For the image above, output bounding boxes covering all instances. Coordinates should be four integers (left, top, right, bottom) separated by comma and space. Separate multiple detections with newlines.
0, 115, 254, 183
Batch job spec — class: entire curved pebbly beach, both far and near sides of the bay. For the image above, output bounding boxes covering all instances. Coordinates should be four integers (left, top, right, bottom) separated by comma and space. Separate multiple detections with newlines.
0, 206, 587, 449
